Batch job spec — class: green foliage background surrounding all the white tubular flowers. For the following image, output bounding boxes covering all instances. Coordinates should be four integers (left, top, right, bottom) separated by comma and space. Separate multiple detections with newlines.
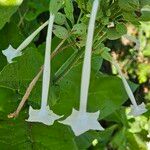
0, 0, 150, 150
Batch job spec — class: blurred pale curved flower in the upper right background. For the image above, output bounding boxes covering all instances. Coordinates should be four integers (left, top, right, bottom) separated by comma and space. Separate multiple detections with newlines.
122, 34, 141, 50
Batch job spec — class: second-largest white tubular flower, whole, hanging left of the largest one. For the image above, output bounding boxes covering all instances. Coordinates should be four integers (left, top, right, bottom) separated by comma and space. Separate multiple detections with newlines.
27, 14, 61, 125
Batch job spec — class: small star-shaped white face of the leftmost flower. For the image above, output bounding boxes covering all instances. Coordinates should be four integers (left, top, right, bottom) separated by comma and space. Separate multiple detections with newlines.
2, 45, 22, 63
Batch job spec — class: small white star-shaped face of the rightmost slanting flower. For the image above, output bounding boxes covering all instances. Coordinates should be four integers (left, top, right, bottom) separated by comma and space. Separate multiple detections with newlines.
129, 103, 147, 117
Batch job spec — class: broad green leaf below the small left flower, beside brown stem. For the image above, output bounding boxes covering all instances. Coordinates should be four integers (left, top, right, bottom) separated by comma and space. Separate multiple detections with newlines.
0, 48, 43, 90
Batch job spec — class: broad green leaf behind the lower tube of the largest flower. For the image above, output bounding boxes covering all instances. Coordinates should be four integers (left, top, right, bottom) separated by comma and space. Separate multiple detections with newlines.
52, 60, 137, 118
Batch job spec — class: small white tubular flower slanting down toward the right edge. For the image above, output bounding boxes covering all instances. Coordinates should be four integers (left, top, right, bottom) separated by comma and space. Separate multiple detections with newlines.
112, 60, 147, 117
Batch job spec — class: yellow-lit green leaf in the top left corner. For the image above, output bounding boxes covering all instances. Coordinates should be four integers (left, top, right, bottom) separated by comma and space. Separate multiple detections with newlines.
0, 0, 22, 29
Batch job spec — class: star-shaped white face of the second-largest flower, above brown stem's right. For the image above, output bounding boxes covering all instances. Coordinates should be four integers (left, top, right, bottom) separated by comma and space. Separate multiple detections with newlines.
26, 106, 62, 125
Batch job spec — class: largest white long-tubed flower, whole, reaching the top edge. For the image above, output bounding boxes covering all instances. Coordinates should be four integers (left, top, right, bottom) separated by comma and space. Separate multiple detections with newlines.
59, 0, 104, 136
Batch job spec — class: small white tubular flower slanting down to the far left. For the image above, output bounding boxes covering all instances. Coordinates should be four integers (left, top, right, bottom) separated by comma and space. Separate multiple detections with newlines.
2, 21, 48, 63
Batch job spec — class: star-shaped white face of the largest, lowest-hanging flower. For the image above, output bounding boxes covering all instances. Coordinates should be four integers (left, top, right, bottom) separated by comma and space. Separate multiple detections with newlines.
59, 109, 104, 136
